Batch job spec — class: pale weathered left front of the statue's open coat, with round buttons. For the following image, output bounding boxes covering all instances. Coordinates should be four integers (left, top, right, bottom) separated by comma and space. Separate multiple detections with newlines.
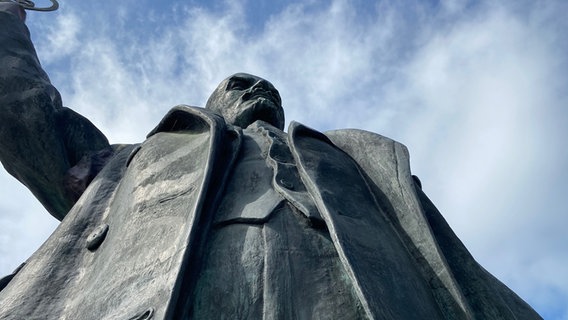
0, 106, 239, 319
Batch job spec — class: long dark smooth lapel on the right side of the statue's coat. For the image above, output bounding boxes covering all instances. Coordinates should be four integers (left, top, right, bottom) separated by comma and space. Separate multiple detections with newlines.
288, 122, 441, 319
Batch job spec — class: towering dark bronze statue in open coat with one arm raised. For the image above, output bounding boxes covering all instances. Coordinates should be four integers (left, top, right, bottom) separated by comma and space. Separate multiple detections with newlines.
0, 3, 540, 319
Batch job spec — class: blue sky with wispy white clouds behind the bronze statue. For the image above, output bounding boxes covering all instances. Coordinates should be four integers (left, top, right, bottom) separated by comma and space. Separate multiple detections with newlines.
0, 0, 568, 320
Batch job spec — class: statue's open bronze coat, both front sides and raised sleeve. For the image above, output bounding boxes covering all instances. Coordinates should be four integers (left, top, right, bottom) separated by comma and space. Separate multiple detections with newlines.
0, 10, 540, 319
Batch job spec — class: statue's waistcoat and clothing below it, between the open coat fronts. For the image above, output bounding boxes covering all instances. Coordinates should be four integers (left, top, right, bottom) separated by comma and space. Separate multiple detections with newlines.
188, 125, 363, 319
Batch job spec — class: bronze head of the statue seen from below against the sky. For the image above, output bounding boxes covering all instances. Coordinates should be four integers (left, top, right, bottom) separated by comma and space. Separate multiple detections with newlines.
206, 73, 284, 130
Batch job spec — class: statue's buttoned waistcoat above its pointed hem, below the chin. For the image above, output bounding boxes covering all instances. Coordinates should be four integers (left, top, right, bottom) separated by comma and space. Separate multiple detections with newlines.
214, 125, 323, 224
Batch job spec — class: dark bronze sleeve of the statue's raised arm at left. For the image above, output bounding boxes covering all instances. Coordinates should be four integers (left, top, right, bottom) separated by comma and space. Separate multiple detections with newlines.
0, 12, 109, 220
